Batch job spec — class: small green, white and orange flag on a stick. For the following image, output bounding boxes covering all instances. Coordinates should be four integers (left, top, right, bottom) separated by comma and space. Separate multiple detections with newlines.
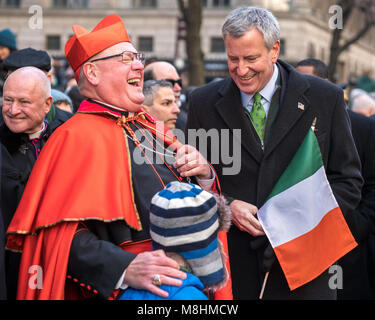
258, 129, 357, 290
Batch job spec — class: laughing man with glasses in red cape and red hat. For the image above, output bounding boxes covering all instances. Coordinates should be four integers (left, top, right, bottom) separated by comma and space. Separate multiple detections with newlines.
7, 15, 229, 299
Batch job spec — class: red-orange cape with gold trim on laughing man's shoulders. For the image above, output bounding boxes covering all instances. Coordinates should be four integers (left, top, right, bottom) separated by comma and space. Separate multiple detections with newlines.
7, 101, 229, 300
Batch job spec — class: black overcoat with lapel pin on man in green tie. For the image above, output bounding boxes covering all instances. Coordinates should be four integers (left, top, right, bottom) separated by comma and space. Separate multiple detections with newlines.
187, 61, 363, 299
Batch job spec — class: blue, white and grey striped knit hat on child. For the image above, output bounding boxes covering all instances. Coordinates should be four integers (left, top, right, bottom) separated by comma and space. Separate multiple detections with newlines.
150, 181, 226, 288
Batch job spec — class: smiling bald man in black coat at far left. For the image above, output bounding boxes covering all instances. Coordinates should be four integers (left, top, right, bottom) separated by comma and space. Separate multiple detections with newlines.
0, 67, 56, 299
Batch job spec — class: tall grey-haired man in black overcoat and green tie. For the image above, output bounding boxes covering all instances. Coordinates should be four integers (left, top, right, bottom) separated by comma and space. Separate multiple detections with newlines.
187, 7, 363, 299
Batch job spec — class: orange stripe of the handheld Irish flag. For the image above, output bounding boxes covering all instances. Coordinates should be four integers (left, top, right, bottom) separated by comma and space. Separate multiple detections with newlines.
274, 207, 357, 290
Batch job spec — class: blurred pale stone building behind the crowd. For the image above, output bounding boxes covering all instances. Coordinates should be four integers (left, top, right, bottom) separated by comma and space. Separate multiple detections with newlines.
0, 0, 375, 82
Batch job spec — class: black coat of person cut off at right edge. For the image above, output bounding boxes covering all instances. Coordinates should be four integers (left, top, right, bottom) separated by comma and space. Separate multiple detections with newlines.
338, 110, 375, 299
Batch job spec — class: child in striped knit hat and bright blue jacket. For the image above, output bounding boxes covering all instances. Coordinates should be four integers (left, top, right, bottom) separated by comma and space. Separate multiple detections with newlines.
120, 181, 231, 300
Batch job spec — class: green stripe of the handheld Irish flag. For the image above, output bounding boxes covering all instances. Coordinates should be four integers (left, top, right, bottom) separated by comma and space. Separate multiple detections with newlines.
267, 129, 323, 200
